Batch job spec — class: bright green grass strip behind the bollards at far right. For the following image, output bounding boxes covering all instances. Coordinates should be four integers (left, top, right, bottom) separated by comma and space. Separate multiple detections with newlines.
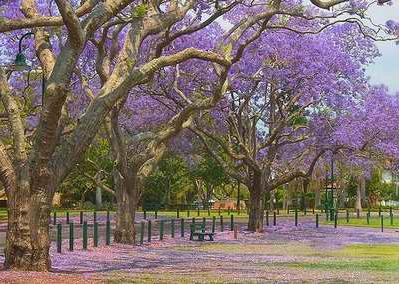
322, 216, 399, 229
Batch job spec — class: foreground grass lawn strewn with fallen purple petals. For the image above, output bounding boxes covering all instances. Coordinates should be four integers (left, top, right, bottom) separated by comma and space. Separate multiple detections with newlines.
107, 242, 399, 283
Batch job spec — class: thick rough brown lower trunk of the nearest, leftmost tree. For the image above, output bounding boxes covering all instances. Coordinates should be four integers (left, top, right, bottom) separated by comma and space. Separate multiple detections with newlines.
4, 175, 53, 271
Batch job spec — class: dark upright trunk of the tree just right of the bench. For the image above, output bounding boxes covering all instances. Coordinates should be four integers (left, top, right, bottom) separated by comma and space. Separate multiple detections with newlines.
248, 174, 264, 232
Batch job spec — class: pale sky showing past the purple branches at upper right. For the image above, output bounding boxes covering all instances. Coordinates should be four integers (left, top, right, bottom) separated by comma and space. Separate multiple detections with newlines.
367, 0, 399, 93
